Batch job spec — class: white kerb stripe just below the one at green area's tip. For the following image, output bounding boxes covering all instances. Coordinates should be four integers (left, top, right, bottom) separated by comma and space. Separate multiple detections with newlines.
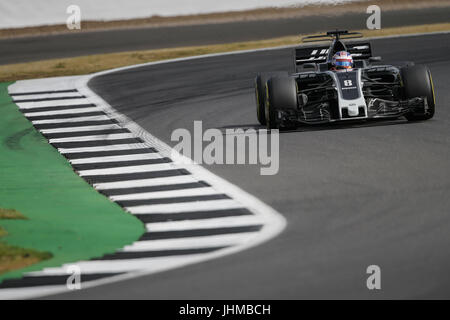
122, 232, 257, 252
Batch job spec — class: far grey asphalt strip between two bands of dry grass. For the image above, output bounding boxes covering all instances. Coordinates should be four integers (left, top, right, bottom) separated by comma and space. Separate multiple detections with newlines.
0, 7, 450, 65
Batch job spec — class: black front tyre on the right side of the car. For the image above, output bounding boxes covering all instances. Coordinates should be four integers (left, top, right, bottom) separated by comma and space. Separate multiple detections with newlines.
401, 65, 436, 121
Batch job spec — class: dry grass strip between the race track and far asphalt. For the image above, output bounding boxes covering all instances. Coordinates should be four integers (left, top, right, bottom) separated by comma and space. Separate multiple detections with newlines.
0, 23, 450, 81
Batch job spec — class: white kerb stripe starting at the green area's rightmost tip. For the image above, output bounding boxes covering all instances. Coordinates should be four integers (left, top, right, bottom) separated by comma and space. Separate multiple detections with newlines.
145, 215, 261, 232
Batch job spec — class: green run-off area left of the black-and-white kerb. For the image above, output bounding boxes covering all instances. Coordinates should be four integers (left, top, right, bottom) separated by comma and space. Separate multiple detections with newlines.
0, 83, 144, 282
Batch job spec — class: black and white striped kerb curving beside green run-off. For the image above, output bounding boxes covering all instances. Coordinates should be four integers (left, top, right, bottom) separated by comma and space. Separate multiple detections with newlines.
0, 80, 284, 298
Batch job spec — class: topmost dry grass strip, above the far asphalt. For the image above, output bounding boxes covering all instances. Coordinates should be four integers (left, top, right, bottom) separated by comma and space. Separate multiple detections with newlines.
0, 0, 450, 38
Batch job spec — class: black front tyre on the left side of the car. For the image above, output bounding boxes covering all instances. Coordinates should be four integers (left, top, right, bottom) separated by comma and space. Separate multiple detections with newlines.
266, 77, 298, 129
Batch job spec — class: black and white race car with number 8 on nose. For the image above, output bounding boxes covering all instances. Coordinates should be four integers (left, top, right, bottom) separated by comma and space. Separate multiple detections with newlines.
255, 30, 435, 129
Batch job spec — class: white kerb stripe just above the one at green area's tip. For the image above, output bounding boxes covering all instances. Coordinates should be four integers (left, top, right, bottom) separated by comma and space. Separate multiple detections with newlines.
125, 199, 244, 214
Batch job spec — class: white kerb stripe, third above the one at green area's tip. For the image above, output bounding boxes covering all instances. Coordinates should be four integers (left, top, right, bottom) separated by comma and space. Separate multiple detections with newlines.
94, 175, 198, 190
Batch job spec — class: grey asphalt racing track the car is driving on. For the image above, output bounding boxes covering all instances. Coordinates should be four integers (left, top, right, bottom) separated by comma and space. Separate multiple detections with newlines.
44, 34, 450, 299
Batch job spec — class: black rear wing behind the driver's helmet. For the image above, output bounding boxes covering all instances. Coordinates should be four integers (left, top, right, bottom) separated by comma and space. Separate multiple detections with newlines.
294, 42, 372, 70
